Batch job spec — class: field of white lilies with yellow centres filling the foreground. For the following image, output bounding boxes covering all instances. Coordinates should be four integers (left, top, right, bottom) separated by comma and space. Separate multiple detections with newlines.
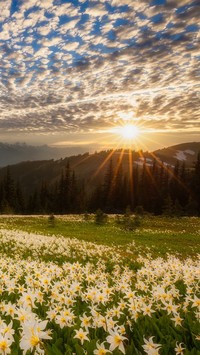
0, 229, 200, 355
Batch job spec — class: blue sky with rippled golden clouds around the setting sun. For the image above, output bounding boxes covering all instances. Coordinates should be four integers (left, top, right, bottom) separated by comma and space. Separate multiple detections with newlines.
0, 0, 200, 151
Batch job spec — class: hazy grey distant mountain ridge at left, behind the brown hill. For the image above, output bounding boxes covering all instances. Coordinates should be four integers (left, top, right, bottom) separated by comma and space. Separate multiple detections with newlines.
0, 143, 88, 167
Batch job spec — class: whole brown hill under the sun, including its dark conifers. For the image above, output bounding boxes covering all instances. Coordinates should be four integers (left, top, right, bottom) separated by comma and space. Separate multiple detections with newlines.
0, 143, 200, 215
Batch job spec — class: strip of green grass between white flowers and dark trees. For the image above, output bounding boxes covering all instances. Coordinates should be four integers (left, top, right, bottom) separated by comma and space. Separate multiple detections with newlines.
0, 216, 200, 257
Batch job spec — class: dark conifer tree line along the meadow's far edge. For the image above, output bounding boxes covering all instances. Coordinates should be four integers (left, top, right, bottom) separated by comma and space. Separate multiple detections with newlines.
0, 153, 200, 216
